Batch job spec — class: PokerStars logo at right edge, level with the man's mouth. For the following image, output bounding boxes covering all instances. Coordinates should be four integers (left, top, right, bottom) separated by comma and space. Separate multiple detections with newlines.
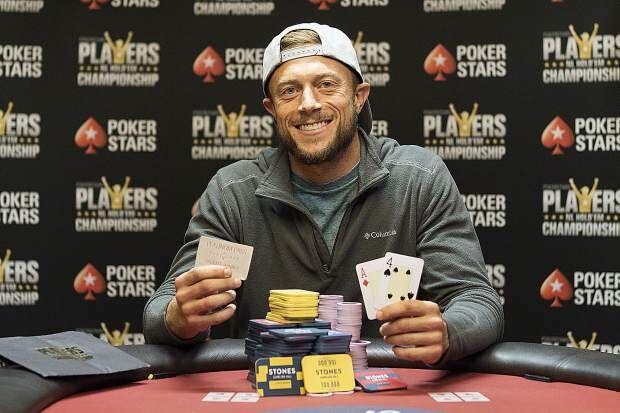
541, 116, 620, 155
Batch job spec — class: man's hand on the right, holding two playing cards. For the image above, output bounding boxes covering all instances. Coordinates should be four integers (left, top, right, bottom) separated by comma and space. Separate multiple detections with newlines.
377, 300, 449, 364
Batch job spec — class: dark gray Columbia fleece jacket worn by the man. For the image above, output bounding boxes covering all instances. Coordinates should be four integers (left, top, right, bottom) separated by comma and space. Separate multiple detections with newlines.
144, 129, 504, 361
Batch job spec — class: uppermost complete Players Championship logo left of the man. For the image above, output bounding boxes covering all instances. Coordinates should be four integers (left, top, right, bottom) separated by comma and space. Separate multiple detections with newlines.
77, 31, 160, 87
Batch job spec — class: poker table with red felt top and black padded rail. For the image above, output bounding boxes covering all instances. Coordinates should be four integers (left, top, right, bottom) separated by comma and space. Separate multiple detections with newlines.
0, 339, 620, 413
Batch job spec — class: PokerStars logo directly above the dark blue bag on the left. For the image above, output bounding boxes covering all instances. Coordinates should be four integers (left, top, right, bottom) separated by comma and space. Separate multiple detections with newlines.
73, 263, 155, 301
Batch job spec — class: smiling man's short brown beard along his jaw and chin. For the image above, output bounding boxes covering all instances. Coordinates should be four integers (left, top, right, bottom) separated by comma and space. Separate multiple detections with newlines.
276, 104, 358, 165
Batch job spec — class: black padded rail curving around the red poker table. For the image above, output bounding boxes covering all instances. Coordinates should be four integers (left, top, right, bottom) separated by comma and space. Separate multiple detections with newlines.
0, 339, 620, 413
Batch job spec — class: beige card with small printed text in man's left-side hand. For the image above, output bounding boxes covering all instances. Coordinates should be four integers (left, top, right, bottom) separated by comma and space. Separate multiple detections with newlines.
194, 236, 254, 280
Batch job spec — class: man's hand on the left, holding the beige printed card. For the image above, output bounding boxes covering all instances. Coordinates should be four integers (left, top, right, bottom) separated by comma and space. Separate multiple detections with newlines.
166, 265, 241, 339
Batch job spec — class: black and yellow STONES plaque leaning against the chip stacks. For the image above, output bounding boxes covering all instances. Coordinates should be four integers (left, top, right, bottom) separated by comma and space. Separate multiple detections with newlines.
255, 357, 306, 397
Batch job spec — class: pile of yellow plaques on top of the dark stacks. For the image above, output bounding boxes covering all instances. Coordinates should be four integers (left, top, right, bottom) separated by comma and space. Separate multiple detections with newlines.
266, 289, 319, 324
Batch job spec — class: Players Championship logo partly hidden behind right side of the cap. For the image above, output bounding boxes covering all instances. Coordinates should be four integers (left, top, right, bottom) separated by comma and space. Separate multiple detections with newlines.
353, 31, 390, 86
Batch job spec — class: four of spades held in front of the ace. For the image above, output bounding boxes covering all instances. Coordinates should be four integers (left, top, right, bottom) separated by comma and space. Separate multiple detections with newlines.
375, 252, 424, 308
